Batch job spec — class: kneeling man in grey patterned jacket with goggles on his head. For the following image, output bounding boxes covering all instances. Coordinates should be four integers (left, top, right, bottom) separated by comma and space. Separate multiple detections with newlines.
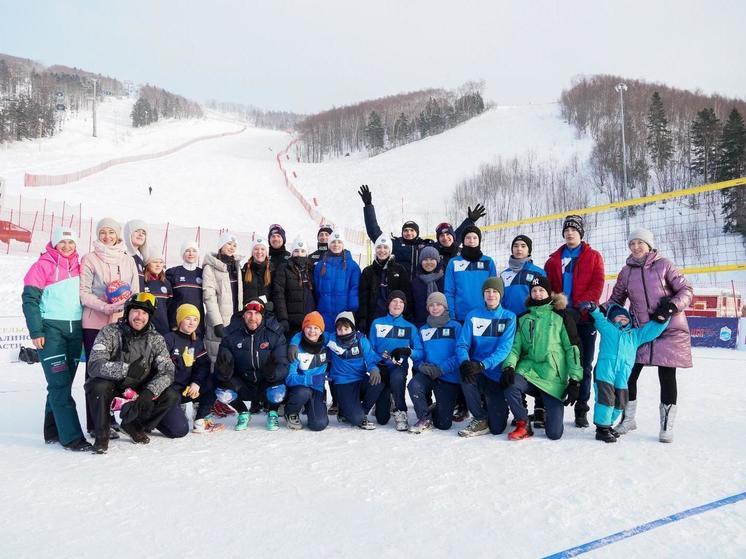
85, 293, 189, 454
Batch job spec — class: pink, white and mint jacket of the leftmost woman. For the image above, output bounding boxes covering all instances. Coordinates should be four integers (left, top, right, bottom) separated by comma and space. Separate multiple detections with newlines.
21, 243, 83, 339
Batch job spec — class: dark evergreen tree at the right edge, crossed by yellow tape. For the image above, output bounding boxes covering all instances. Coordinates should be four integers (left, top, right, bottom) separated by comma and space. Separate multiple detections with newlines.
718, 108, 746, 236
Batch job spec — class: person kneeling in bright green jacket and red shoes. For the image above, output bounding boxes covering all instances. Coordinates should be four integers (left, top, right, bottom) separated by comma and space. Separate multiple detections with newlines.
502, 276, 583, 441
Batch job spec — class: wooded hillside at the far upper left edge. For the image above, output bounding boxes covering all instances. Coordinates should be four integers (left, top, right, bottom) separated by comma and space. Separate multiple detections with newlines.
0, 55, 124, 143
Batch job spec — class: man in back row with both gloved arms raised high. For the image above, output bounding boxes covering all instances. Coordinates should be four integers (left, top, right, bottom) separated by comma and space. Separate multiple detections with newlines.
358, 184, 487, 282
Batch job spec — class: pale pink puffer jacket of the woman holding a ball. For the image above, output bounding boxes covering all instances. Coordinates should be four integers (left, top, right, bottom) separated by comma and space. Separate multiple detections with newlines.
80, 241, 140, 330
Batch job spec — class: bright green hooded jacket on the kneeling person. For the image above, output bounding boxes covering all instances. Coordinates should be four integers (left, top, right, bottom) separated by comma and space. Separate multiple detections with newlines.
503, 293, 583, 400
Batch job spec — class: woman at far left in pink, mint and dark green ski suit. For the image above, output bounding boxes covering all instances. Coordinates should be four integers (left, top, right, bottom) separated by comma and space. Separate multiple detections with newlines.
21, 227, 93, 451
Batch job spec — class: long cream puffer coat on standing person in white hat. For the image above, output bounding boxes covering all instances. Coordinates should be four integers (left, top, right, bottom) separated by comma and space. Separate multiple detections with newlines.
202, 252, 243, 361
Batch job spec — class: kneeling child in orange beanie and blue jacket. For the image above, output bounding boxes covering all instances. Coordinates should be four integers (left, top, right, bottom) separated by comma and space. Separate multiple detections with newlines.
285, 311, 329, 431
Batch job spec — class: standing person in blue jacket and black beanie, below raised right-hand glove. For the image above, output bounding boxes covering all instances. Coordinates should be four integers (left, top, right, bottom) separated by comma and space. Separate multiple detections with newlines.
444, 225, 497, 322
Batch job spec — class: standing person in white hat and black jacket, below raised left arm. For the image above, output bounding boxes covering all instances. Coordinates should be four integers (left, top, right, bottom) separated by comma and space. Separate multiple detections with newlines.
357, 235, 412, 335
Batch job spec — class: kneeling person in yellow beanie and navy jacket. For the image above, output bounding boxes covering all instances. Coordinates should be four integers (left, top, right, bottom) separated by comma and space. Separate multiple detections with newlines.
163, 303, 225, 433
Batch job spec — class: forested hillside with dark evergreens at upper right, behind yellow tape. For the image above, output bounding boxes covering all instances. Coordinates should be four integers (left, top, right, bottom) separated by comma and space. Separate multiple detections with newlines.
560, 75, 746, 235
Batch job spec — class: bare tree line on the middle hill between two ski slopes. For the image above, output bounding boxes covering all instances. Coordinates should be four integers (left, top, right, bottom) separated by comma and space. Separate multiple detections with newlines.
297, 82, 485, 163
